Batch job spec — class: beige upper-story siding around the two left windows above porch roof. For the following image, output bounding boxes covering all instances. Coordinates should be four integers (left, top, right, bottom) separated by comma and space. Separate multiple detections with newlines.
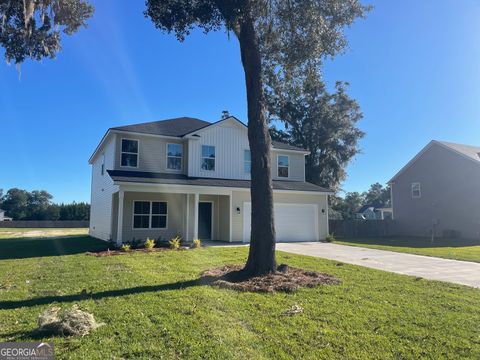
115, 134, 188, 174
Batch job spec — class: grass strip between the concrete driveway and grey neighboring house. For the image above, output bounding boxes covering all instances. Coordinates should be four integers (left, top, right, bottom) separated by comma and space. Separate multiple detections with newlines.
335, 237, 480, 262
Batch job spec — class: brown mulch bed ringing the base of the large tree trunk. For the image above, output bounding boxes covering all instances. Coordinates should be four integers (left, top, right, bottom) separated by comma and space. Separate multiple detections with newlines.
201, 265, 340, 293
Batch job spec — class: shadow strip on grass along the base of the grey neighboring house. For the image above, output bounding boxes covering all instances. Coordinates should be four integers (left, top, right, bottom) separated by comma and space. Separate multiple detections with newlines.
338, 237, 480, 248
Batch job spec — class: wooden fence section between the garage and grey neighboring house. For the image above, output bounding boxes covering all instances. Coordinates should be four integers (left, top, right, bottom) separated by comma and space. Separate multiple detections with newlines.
329, 220, 397, 238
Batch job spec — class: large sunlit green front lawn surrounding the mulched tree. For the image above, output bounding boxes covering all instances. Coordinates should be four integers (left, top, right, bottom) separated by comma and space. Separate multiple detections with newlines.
0, 232, 480, 359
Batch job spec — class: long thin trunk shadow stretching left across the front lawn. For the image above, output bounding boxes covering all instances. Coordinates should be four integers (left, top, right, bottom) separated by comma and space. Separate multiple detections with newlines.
0, 278, 201, 310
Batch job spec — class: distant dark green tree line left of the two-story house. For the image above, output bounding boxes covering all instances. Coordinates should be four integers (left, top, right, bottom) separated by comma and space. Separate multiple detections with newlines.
0, 188, 90, 220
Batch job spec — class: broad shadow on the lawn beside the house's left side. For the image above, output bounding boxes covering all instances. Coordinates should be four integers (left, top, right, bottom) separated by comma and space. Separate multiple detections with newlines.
0, 235, 108, 260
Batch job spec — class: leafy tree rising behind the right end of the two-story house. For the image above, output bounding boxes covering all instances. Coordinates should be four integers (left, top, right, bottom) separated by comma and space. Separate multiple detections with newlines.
267, 68, 364, 189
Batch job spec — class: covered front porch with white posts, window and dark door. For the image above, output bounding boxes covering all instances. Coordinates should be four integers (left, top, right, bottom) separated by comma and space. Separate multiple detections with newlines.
112, 184, 232, 245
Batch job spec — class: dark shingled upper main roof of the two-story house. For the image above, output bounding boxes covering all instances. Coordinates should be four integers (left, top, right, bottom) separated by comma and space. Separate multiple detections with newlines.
110, 117, 305, 151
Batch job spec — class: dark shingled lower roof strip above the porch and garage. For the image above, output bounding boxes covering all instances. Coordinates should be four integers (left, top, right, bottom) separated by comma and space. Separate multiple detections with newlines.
107, 170, 332, 193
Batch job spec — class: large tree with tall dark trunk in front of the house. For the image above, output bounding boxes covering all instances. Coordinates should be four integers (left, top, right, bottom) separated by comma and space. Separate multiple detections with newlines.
145, 0, 368, 276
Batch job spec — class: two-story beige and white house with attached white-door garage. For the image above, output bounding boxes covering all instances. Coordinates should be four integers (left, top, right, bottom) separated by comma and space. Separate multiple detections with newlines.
89, 116, 331, 244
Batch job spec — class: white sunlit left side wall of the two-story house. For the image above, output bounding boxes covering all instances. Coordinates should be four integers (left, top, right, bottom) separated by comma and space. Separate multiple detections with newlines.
89, 136, 118, 240
